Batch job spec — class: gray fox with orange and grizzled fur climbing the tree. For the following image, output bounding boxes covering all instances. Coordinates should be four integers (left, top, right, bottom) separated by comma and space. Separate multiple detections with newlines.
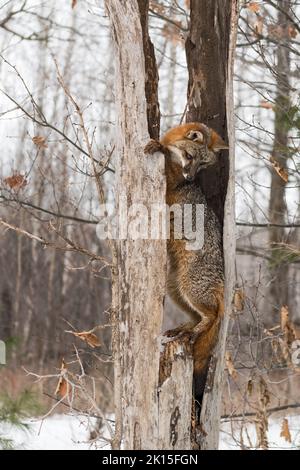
145, 122, 228, 401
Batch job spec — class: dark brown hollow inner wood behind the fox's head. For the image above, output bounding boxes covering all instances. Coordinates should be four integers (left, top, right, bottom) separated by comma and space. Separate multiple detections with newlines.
185, 0, 232, 224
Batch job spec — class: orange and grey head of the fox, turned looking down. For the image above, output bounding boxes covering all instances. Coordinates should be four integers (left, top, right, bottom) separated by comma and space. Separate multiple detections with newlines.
160, 122, 228, 181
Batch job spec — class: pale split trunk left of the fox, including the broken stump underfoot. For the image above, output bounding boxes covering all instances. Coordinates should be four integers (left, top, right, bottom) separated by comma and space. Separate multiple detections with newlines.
106, 0, 193, 449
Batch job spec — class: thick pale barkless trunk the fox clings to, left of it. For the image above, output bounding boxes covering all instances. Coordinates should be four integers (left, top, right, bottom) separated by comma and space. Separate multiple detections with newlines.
106, 0, 166, 449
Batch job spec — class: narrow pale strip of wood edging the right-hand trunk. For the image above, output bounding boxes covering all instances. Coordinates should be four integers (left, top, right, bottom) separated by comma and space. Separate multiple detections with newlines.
198, 0, 238, 450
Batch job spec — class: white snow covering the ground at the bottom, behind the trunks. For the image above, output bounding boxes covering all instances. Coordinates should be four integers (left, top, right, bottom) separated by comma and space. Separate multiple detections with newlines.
0, 415, 300, 450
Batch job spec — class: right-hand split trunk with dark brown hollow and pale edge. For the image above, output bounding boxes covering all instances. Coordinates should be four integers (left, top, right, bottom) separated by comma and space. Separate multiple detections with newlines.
186, 0, 238, 449
